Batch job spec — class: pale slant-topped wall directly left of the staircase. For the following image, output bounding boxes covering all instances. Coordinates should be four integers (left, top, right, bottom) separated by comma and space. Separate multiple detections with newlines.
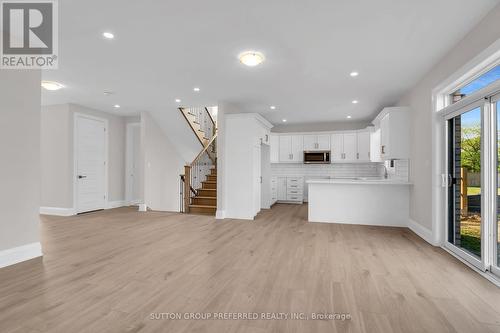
141, 112, 186, 212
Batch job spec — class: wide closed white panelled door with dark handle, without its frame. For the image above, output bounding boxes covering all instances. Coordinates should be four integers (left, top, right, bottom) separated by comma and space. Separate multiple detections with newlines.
75, 115, 106, 213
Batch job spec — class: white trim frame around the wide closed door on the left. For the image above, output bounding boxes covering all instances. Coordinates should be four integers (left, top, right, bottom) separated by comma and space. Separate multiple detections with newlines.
73, 112, 109, 214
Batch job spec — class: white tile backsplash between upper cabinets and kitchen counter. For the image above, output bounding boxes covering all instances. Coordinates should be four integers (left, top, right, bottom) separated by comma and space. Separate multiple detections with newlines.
271, 160, 409, 181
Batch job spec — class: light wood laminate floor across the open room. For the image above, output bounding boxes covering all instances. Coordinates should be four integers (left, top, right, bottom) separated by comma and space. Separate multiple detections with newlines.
0, 205, 500, 333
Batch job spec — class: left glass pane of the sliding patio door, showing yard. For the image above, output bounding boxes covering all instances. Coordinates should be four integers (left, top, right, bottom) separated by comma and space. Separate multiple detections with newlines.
448, 108, 482, 258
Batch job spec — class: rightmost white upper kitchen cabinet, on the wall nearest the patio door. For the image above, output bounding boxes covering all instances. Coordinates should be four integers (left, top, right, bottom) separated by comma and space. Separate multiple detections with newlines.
375, 107, 410, 160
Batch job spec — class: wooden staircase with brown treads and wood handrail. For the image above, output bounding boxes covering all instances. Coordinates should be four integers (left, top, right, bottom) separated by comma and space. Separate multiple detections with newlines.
179, 108, 217, 215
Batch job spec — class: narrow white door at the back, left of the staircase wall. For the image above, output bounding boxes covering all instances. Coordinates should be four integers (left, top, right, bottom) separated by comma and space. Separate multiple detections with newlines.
126, 123, 141, 204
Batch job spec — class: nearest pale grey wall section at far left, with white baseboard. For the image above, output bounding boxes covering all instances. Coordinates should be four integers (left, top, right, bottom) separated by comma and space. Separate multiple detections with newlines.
0, 70, 41, 267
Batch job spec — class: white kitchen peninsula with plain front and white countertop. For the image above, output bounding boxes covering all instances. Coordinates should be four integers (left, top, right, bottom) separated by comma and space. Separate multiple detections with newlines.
306, 178, 411, 227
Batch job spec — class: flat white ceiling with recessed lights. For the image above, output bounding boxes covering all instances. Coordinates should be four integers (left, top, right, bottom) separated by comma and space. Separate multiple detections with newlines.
42, 0, 499, 124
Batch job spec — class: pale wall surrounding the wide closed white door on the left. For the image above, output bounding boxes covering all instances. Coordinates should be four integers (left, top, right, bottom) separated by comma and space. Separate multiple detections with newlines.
40, 104, 130, 208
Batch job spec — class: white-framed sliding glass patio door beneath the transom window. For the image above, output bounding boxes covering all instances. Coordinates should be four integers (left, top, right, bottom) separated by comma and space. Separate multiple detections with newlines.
443, 94, 500, 276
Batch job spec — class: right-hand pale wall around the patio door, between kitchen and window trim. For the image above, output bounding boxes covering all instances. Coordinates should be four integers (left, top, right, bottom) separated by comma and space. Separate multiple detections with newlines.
398, 5, 500, 237
